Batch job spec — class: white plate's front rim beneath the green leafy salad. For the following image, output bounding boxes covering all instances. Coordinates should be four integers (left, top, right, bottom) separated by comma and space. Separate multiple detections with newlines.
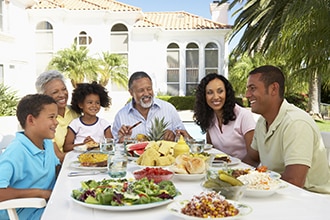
71, 197, 173, 211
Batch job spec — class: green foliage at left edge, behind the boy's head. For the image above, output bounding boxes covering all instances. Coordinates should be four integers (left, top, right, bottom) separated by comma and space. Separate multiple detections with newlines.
0, 84, 19, 116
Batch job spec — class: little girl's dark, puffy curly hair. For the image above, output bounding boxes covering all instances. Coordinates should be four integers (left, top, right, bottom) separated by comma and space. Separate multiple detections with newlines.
71, 81, 111, 114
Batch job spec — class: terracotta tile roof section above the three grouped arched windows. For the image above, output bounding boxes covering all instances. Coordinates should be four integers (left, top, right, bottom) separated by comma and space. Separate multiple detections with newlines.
135, 11, 231, 30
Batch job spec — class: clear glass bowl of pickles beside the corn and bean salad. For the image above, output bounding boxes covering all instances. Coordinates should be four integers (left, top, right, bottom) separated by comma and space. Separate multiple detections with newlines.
202, 170, 247, 201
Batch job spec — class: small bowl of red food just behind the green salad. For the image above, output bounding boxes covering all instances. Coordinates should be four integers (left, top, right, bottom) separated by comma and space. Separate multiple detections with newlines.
133, 167, 174, 183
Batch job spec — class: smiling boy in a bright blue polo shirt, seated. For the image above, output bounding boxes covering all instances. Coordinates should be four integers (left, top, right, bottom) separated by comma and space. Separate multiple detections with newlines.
0, 94, 60, 219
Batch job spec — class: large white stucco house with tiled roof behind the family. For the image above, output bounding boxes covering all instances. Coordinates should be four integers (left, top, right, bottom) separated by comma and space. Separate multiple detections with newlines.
0, 0, 231, 95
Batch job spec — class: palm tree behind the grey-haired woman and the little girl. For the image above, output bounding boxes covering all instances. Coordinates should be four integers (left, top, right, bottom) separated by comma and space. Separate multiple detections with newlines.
48, 44, 98, 88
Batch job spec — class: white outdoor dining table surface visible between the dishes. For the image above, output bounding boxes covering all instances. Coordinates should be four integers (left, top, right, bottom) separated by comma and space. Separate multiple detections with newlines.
41, 149, 330, 220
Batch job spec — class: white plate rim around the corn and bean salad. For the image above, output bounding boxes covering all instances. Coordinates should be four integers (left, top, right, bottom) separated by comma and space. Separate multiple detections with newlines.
167, 200, 252, 220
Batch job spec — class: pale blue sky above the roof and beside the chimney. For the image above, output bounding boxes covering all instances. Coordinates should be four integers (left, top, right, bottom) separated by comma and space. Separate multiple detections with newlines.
117, 0, 241, 51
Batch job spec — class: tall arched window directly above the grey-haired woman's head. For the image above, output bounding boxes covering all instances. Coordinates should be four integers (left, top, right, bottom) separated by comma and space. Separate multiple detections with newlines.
35, 21, 54, 74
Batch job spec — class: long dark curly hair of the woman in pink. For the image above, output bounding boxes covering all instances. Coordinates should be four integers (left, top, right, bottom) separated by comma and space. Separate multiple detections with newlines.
193, 73, 236, 133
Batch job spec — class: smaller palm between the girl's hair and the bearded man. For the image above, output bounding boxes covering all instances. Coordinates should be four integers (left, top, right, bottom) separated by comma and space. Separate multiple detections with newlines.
97, 52, 128, 87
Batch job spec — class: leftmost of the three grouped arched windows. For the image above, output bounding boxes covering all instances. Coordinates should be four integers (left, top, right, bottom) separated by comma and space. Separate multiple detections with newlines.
166, 43, 180, 95
